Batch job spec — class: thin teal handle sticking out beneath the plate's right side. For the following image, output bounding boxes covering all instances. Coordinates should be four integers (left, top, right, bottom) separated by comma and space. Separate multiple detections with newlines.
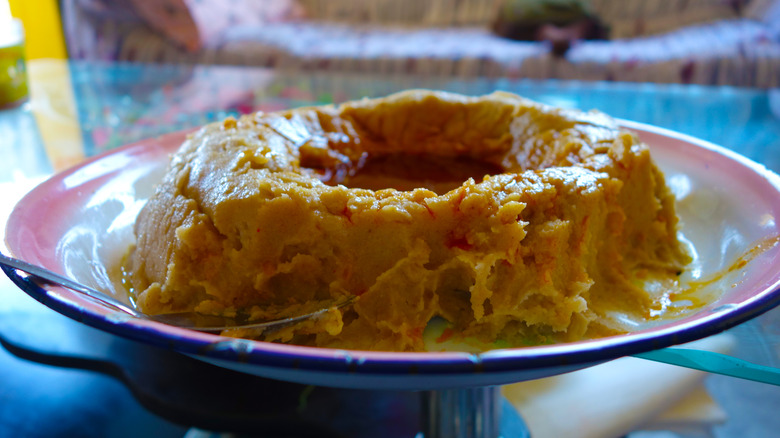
634, 348, 780, 386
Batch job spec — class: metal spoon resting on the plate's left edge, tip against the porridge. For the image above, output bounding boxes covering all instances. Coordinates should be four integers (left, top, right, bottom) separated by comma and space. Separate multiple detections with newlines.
0, 253, 355, 333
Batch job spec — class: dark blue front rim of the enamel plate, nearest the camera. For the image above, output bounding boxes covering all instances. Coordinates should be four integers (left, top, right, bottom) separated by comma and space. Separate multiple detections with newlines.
2, 267, 780, 375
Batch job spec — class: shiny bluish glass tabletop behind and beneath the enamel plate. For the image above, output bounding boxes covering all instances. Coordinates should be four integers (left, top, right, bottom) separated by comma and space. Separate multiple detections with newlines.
0, 61, 780, 437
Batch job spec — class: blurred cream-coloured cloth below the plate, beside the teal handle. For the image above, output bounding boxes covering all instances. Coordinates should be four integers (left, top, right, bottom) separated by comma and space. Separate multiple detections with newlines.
503, 334, 735, 438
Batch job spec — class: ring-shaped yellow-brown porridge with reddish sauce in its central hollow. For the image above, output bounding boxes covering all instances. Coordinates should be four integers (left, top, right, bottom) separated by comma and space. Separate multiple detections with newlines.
125, 90, 690, 351
